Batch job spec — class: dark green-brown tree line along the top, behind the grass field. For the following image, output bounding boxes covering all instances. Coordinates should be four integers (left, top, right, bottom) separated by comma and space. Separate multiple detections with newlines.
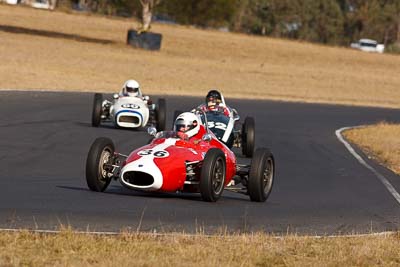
65, 0, 400, 47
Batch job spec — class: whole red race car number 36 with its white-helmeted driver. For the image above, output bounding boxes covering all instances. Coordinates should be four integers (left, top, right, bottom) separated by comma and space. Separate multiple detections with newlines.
86, 112, 275, 202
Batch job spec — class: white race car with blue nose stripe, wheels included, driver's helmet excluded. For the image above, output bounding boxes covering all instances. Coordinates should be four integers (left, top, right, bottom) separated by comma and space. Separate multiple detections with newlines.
92, 93, 166, 131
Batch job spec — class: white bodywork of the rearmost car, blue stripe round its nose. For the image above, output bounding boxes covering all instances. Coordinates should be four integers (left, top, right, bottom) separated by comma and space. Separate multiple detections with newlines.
110, 96, 149, 128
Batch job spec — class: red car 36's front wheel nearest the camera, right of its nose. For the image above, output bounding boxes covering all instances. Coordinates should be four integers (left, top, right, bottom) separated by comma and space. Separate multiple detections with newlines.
200, 148, 226, 202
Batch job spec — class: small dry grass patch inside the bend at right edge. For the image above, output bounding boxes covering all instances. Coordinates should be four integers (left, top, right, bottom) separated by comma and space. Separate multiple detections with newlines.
344, 122, 400, 174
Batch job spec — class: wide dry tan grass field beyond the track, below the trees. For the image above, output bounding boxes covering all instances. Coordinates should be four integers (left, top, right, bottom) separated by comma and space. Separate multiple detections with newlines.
0, 5, 400, 107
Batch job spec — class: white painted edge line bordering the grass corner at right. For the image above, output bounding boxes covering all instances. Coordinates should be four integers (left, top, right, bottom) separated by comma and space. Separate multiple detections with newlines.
335, 125, 400, 204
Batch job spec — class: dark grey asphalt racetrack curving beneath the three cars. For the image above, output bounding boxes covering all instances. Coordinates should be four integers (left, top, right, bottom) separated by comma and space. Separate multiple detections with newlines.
0, 91, 400, 235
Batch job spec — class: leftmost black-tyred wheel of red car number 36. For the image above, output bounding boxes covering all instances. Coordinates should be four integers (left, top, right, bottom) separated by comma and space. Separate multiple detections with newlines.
86, 137, 114, 192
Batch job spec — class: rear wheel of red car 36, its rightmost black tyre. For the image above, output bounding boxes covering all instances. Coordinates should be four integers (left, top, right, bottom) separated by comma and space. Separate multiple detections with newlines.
247, 148, 275, 202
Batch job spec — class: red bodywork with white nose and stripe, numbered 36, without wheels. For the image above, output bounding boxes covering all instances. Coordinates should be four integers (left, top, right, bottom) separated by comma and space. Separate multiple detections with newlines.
120, 126, 236, 192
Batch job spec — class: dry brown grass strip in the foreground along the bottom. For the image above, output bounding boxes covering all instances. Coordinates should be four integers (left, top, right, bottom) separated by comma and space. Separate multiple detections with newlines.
0, 231, 400, 266
